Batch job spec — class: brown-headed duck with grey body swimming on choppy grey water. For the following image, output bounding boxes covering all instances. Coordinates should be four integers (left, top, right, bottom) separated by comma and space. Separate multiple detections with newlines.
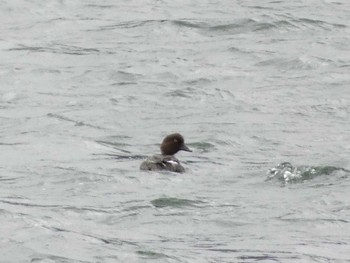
140, 133, 192, 173
